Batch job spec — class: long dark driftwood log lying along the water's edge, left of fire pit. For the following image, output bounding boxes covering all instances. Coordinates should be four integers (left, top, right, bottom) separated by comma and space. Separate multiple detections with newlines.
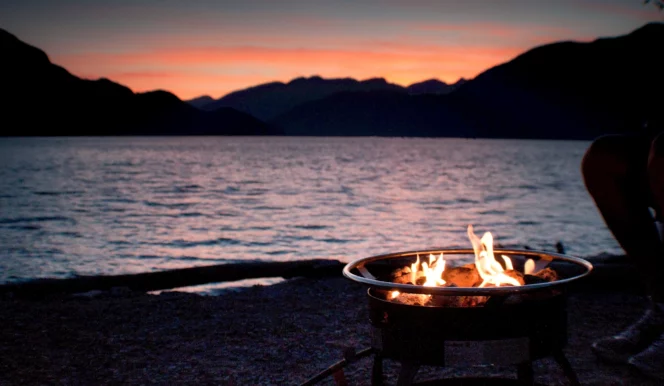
0, 259, 344, 298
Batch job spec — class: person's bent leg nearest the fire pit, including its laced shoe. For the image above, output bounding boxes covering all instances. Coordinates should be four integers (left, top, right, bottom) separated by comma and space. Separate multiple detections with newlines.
582, 136, 664, 364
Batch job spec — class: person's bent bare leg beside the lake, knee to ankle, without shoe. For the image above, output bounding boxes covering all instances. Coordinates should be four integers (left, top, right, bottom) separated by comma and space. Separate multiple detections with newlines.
582, 136, 664, 296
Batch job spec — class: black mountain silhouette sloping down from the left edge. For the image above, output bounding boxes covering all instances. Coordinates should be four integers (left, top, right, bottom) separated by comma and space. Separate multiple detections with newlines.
0, 30, 272, 136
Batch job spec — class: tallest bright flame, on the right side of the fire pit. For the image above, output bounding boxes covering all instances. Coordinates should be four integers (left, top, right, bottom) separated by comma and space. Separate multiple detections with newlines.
468, 225, 521, 287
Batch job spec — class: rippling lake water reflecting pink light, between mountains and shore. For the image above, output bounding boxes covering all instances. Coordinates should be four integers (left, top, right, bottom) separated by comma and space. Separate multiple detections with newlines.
0, 137, 620, 292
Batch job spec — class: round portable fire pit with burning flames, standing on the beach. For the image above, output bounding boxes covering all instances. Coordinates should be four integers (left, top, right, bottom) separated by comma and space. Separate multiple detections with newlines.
305, 226, 592, 386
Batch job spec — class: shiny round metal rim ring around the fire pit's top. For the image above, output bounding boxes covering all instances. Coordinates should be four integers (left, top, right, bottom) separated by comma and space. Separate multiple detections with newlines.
343, 248, 593, 296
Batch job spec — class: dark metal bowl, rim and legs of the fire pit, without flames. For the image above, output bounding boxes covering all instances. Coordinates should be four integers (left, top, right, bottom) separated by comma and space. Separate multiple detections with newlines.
343, 249, 592, 386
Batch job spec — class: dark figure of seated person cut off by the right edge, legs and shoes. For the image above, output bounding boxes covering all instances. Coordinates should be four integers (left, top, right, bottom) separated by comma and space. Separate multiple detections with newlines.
581, 124, 664, 380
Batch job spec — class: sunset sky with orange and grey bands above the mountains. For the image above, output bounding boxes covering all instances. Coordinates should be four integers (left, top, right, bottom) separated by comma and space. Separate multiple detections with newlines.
0, 0, 664, 99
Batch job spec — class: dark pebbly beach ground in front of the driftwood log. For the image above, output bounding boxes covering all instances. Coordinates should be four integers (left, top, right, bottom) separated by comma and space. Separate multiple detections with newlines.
0, 277, 657, 385
